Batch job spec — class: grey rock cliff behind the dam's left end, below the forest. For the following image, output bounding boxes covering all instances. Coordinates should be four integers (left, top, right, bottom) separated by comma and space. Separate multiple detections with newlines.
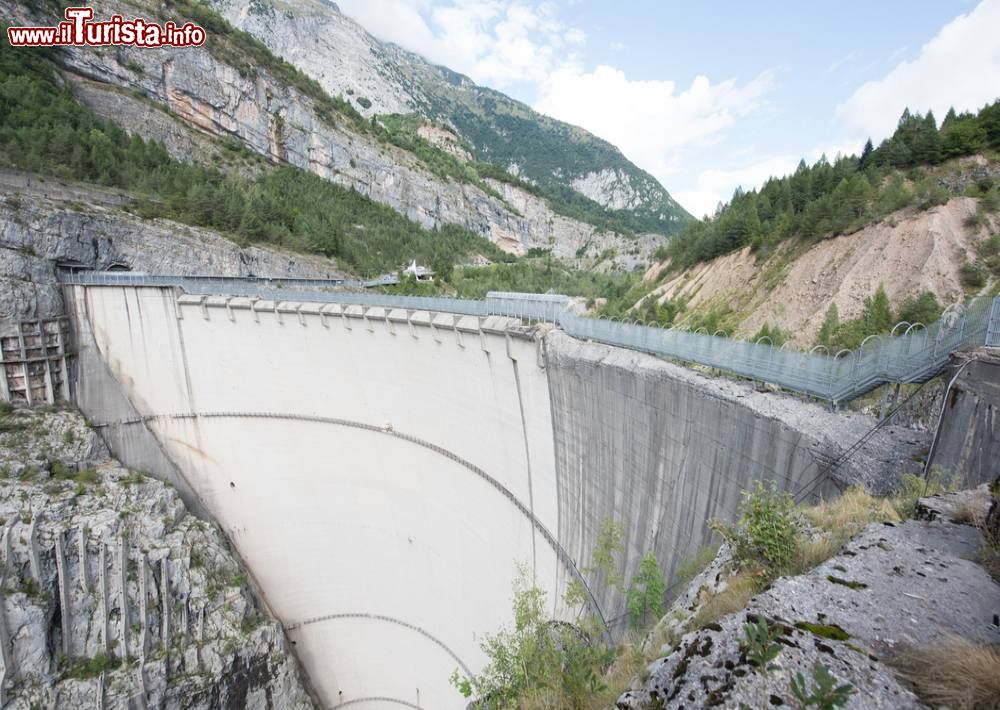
0, 172, 342, 323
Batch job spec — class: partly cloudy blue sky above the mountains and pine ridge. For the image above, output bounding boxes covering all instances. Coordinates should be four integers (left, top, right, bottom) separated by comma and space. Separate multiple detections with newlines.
338, 0, 1000, 216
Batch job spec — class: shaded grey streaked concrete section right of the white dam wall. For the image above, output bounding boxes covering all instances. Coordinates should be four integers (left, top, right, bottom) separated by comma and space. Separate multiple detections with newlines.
546, 332, 840, 628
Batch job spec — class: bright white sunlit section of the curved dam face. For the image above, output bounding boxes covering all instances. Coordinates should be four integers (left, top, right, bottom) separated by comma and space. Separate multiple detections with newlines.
68, 288, 572, 708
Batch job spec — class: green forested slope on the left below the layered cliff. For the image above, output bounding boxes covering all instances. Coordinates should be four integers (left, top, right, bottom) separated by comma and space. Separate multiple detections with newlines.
0, 33, 504, 275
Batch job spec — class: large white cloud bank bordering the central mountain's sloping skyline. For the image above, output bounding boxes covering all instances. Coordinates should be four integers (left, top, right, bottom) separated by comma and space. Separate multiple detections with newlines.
338, 0, 774, 218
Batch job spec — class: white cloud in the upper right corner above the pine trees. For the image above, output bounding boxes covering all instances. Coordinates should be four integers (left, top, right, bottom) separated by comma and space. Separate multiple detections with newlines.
837, 0, 1000, 142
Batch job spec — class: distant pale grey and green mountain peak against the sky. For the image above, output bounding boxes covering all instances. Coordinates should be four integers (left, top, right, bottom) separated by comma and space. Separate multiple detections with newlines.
204, 0, 688, 233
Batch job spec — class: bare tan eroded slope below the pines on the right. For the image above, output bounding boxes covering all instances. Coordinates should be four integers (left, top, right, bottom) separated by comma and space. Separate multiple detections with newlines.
646, 188, 998, 348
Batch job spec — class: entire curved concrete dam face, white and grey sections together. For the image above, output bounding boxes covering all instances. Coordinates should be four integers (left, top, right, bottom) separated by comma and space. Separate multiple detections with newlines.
66, 286, 861, 708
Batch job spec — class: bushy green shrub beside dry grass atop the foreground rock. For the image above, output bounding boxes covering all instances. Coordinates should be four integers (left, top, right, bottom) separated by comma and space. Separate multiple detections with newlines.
710, 481, 797, 576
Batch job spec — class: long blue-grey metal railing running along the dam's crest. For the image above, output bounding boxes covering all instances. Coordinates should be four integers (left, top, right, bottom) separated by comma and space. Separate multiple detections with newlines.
60, 272, 1000, 403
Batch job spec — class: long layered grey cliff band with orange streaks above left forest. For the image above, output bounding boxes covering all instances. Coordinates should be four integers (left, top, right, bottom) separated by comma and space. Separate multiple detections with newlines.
0, 0, 672, 268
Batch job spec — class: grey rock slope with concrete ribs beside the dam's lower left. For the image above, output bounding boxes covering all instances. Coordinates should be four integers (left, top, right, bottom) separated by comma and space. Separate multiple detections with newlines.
0, 411, 313, 710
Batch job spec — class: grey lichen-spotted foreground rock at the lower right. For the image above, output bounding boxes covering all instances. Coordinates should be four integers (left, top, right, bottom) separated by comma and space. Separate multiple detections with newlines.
617, 520, 1000, 710
